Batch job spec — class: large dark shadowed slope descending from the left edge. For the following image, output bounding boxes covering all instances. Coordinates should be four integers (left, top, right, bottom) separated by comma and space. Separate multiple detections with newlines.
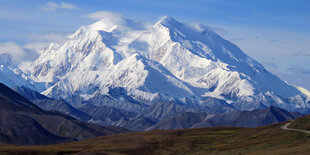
0, 83, 127, 145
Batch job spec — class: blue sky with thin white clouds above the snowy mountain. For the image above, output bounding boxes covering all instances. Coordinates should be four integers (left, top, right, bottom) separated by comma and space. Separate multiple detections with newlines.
0, 0, 310, 89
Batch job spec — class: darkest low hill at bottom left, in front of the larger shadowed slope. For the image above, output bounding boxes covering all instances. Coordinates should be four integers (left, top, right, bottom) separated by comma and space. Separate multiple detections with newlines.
0, 111, 68, 145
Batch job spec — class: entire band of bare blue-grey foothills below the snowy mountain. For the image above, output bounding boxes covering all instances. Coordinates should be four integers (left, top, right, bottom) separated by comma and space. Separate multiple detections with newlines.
13, 84, 303, 131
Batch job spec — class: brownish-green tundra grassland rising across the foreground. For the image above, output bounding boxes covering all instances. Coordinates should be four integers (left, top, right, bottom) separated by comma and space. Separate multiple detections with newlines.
0, 124, 310, 155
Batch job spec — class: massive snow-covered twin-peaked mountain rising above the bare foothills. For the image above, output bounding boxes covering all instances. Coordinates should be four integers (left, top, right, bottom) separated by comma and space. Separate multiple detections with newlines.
26, 16, 310, 112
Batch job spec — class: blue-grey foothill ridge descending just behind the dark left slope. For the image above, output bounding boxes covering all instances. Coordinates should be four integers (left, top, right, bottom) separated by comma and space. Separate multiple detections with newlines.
12, 86, 156, 131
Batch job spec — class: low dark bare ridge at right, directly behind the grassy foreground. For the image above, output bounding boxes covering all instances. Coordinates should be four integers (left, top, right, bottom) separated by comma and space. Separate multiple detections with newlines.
147, 107, 303, 130
